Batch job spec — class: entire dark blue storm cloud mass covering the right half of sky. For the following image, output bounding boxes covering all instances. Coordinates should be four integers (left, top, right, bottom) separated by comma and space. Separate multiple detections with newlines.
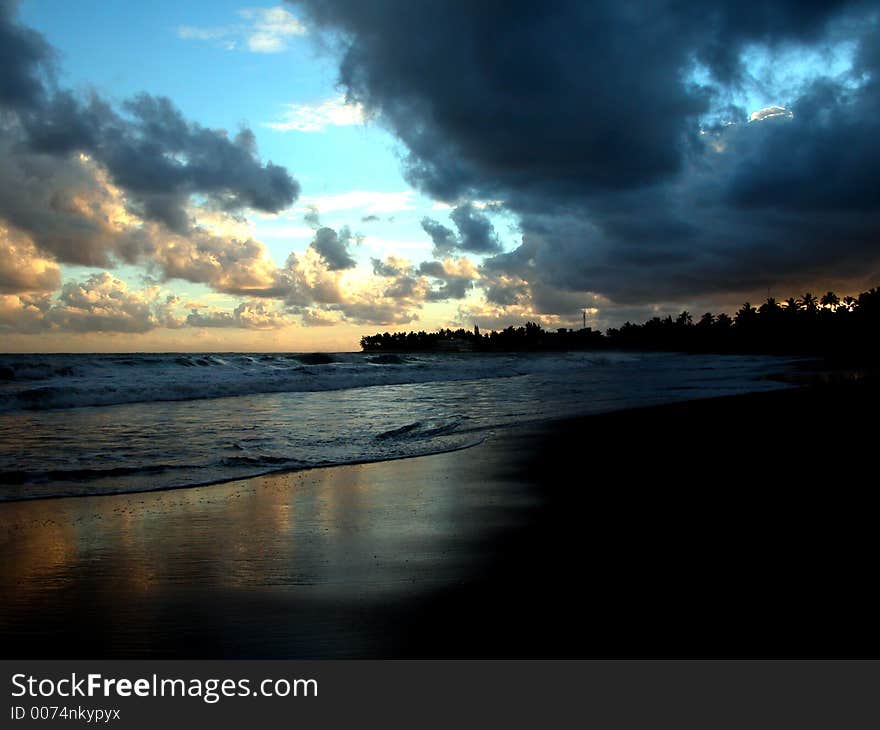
296, 0, 880, 316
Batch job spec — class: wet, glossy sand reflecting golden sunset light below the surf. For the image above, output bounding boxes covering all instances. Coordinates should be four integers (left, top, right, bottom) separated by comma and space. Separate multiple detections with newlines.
0, 440, 532, 655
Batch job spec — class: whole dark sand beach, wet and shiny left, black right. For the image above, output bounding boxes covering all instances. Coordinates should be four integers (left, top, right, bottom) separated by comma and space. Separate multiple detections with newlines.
0, 381, 880, 658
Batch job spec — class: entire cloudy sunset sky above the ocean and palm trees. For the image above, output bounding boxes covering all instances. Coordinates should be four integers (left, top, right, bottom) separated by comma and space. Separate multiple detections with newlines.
0, 0, 880, 352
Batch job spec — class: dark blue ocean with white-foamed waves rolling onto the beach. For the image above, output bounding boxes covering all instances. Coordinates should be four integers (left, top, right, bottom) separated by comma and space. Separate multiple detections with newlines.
0, 352, 796, 501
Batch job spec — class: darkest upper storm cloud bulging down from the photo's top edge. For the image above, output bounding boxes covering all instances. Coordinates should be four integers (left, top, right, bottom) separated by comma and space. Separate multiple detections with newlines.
297, 0, 829, 199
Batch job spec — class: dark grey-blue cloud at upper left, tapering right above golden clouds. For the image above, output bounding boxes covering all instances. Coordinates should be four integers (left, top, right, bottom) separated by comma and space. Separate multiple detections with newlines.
0, 0, 299, 265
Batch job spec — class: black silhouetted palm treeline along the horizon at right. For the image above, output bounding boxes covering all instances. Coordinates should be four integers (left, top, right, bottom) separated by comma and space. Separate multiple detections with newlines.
361, 288, 880, 360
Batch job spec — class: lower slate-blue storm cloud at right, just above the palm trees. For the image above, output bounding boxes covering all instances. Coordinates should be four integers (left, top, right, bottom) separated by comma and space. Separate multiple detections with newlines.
508, 73, 880, 303
